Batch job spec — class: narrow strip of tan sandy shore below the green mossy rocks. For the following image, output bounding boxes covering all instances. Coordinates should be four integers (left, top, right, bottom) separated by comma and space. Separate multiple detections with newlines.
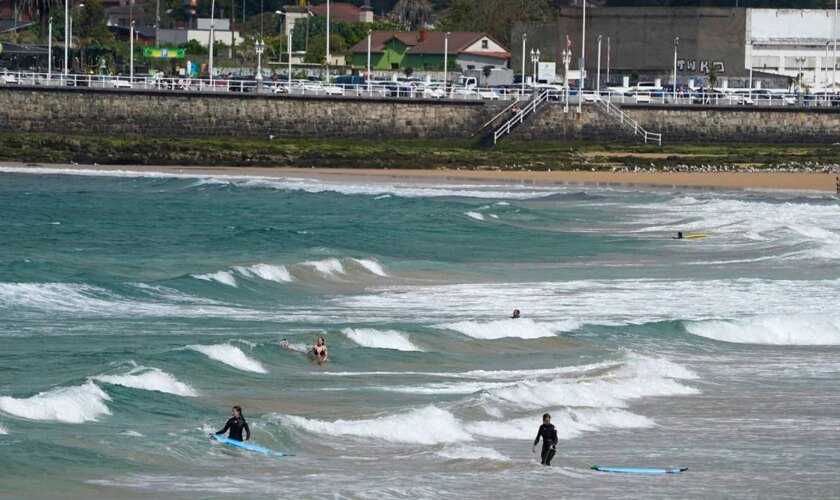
0, 162, 837, 193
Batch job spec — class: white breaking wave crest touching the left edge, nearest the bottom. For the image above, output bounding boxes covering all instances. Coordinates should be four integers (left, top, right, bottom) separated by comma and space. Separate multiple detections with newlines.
0, 382, 111, 424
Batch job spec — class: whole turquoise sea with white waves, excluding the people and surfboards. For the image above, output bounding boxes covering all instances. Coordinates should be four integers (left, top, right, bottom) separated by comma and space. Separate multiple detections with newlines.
0, 167, 840, 499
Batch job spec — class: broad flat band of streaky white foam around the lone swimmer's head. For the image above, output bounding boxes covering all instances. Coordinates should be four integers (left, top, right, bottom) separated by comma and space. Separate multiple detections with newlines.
333, 278, 840, 328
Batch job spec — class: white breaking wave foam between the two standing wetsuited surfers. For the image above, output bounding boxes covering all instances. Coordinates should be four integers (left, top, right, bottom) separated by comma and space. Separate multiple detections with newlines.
281, 406, 472, 444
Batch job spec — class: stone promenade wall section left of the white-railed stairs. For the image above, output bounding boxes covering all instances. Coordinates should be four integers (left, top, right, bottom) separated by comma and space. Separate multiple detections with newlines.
0, 86, 504, 138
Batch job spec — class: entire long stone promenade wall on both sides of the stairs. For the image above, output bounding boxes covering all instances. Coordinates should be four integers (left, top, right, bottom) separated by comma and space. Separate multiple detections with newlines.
0, 86, 840, 144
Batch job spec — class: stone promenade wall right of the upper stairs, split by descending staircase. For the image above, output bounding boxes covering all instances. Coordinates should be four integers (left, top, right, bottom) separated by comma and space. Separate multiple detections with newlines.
514, 103, 840, 144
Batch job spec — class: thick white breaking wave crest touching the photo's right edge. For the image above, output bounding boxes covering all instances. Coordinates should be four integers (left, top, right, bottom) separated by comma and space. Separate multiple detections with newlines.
686, 316, 840, 345
